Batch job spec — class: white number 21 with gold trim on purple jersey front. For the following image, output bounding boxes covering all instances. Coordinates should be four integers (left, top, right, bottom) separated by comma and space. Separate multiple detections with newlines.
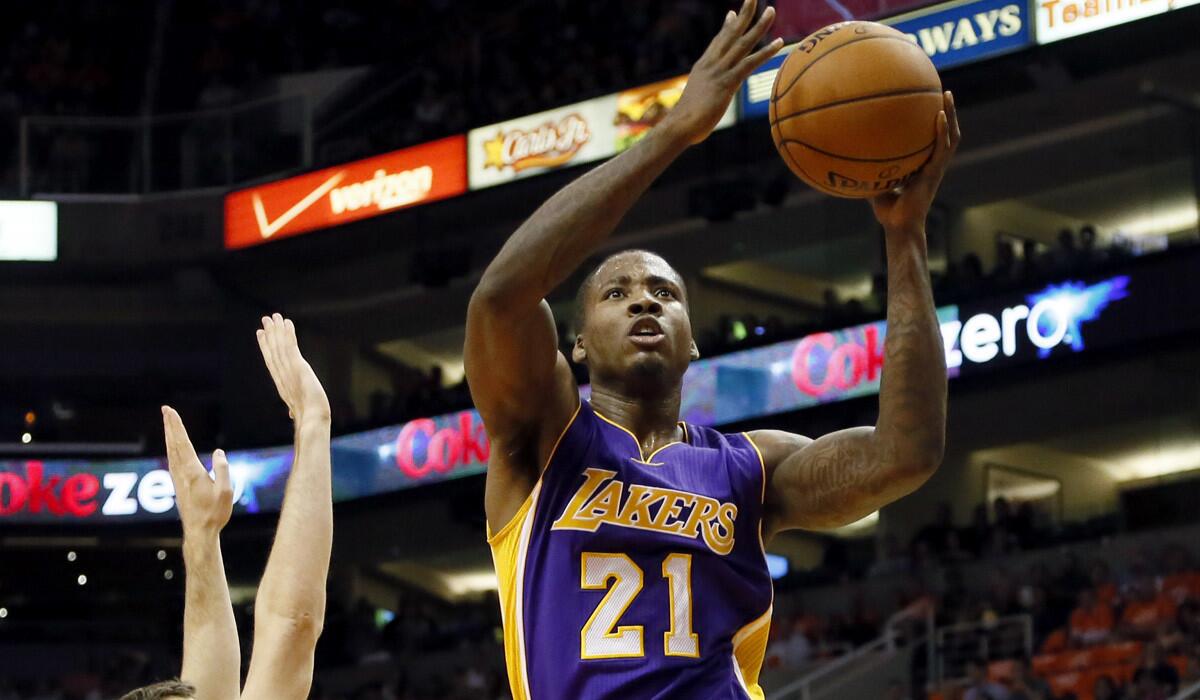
580, 552, 700, 659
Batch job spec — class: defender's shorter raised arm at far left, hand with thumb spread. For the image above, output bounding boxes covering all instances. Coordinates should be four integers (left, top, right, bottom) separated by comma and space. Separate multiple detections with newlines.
162, 406, 241, 700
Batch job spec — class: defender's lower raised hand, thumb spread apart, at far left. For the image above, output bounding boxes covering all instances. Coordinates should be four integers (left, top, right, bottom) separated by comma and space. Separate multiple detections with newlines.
162, 406, 233, 538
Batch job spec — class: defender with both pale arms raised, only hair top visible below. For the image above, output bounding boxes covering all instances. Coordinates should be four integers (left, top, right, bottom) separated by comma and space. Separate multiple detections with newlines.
122, 313, 334, 700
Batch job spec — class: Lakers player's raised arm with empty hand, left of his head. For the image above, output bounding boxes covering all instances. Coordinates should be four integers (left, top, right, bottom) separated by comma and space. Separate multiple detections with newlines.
464, 0, 782, 526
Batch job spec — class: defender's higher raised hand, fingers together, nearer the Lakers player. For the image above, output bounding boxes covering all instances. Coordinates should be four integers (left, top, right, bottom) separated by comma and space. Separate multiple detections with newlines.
256, 313, 329, 423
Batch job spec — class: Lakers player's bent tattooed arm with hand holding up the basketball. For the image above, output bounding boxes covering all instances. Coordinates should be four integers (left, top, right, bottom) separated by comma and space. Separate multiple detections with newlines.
752, 92, 960, 534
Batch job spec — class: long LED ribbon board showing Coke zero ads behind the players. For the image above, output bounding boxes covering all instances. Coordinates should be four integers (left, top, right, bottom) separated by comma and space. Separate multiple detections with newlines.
7, 253, 1200, 525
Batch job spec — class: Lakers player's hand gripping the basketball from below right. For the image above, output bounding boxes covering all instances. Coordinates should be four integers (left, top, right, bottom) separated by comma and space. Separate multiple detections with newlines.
871, 91, 962, 233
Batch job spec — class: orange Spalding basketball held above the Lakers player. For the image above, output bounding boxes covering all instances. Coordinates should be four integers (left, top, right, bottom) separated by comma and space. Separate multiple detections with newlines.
769, 22, 942, 198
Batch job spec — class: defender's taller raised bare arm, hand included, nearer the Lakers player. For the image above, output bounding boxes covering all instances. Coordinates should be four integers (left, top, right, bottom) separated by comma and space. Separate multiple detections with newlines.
244, 313, 334, 700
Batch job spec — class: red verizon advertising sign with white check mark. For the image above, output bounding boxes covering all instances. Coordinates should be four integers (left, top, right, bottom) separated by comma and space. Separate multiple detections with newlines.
226, 136, 467, 250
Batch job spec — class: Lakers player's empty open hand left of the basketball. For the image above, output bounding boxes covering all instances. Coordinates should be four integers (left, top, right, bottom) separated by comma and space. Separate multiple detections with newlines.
664, 0, 784, 143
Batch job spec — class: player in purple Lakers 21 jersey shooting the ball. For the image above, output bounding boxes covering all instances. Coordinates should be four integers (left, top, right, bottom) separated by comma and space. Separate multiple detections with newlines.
464, 0, 959, 700
